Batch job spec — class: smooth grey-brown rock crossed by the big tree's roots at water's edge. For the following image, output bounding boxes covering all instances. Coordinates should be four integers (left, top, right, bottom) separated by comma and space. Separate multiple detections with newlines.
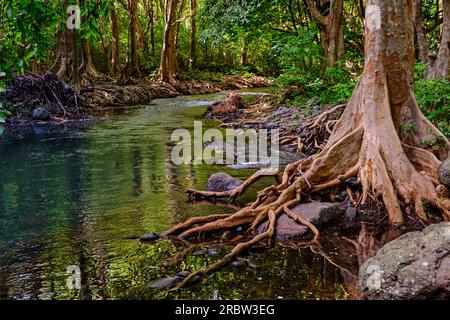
257, 202, 345, 241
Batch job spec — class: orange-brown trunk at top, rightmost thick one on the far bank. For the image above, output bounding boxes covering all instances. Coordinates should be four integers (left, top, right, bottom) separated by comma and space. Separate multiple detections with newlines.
159, 0, 177, 83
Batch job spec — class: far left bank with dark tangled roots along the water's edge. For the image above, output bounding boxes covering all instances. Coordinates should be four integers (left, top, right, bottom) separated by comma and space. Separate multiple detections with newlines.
0, 73, 271, 126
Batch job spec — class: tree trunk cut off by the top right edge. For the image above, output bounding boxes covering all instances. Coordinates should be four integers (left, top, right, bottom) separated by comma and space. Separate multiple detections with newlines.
428, 0, 450, 79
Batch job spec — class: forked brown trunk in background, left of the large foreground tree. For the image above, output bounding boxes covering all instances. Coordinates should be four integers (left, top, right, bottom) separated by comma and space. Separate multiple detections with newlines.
306, 0, 344, 67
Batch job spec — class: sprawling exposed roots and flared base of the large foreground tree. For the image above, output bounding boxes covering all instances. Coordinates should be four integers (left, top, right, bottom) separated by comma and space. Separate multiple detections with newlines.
163, 82, 450, 287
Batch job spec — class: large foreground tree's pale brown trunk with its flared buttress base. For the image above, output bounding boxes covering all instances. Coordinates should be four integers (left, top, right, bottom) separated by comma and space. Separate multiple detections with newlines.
318, 0, 450, 224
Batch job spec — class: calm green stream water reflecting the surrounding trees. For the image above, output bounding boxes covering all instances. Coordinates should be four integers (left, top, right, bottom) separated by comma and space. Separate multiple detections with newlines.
0, 94, 352, 299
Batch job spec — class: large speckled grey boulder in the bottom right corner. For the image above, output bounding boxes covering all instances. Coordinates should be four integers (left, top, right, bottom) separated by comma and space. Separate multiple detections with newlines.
359, 222, 450, 299
